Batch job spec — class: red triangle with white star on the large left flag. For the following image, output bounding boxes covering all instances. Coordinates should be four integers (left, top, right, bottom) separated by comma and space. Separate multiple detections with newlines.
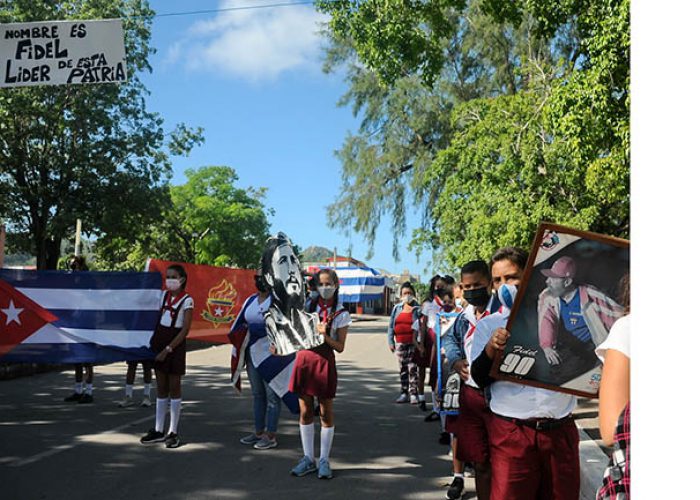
0, 280, 58, 356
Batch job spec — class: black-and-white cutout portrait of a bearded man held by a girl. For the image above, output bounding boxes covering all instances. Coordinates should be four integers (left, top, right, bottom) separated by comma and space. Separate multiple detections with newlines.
261, 233, 323, 356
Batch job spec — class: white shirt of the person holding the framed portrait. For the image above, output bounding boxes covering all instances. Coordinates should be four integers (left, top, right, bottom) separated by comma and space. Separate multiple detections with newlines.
471, 314, 576, 419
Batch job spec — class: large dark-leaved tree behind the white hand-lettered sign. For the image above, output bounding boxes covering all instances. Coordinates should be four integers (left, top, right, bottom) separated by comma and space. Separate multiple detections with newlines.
0, 0, 202, 269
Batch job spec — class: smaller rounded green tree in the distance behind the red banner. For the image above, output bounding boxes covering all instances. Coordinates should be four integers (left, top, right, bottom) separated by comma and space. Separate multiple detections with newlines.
96, 166, 272, 269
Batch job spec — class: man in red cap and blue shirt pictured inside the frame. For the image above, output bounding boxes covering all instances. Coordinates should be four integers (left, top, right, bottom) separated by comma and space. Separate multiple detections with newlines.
537, 256, 623, 385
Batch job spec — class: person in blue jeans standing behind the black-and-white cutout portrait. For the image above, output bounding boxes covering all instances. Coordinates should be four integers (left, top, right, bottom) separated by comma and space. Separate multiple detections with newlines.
238, 269, 280, 450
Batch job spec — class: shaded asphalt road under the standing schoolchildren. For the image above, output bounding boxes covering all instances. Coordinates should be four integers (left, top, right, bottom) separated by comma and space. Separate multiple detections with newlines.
0, 319, 599, 500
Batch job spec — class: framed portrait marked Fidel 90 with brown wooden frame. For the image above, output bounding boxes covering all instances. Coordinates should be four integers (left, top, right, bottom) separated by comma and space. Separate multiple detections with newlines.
491, 224, 630, 398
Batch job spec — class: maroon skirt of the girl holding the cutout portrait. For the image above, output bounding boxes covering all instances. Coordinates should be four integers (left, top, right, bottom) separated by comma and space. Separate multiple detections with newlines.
289, 344, 338, 399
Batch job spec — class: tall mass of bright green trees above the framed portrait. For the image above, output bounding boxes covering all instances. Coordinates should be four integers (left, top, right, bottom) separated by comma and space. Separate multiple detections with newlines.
320, 0, 629, 266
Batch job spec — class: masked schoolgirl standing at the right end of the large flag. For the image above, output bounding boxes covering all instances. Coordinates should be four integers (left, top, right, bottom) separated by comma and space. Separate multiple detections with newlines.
141, 264, 194, 448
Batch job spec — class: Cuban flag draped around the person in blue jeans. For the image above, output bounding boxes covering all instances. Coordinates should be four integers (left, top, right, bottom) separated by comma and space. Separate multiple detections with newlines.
228, 294, 299, 414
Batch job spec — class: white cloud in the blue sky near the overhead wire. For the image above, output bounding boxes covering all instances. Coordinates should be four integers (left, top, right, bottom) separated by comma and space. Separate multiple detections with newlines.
165, 0, 326, 81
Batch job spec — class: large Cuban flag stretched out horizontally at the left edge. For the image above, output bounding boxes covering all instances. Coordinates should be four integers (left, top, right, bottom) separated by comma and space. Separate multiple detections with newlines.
0, 269, 162, 364
